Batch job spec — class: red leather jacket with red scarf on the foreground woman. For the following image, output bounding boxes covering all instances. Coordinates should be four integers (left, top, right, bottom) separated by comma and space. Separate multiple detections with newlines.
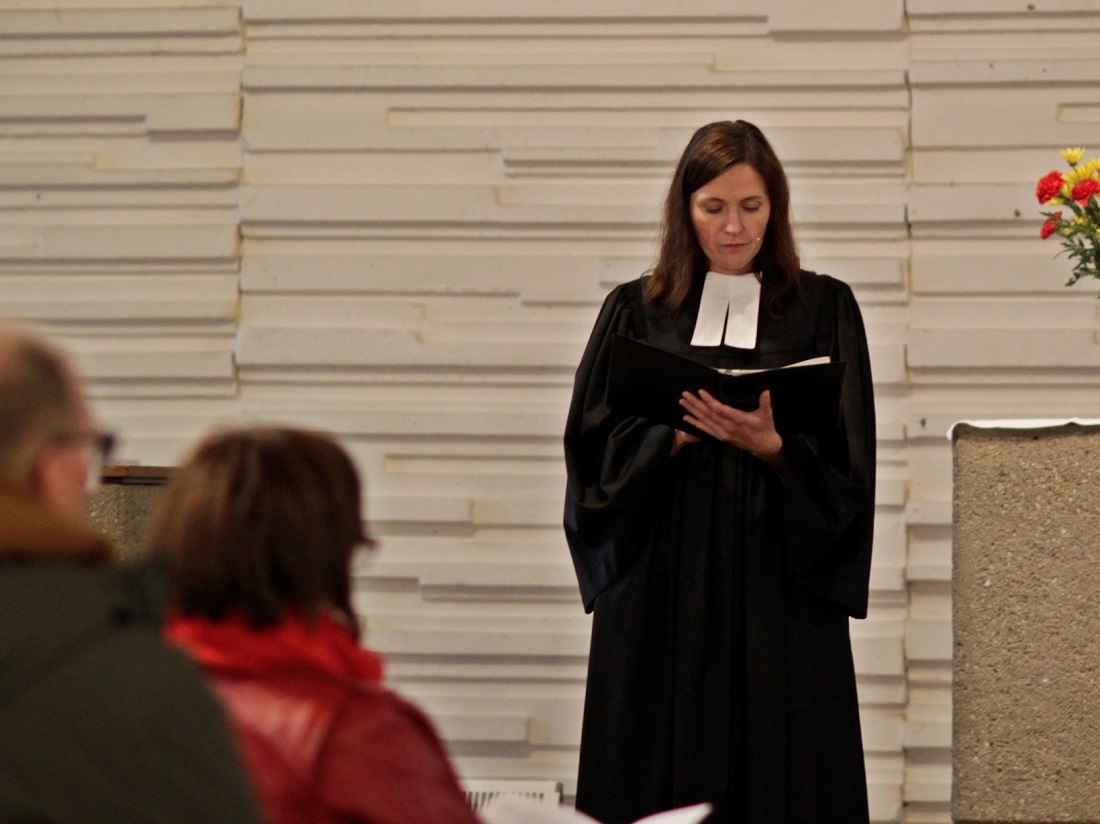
167, 617, 479, 824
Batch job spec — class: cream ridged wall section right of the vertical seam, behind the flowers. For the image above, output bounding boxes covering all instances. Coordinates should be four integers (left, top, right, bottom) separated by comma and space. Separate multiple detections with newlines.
904, 0, 1100, 822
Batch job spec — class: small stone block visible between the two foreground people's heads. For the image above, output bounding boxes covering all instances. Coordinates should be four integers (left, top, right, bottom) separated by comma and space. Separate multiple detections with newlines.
88, 466, 172, 560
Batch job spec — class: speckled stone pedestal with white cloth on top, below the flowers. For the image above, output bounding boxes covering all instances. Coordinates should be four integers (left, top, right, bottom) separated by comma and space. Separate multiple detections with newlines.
953, 421, 1100, 824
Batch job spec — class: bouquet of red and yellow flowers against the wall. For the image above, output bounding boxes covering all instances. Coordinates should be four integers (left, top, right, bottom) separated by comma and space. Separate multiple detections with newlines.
1035, 146, 1100, 286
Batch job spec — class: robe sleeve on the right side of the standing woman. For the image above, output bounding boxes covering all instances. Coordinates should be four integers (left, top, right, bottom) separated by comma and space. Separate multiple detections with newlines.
779, 278, 876, 618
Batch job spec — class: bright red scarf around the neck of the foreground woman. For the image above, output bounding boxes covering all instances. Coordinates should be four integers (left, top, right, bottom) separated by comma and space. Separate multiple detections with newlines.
164, 613, 383, 683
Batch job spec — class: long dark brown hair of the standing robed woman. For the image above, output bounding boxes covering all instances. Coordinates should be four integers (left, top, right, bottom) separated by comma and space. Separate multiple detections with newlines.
646, 120, 800, 314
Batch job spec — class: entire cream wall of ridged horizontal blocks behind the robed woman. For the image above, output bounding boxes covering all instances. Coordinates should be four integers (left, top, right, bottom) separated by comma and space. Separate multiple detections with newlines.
0, 0, 1100, 824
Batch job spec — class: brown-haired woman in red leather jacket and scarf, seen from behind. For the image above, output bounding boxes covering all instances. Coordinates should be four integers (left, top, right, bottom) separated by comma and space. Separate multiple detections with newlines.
149, 428, 477, 824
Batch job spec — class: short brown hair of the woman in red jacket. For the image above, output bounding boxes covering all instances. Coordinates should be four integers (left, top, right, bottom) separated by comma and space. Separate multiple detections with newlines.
147, 427, 372, 630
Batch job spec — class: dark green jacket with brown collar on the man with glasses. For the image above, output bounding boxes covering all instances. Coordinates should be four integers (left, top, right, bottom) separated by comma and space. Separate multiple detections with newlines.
0, 490, 262, 824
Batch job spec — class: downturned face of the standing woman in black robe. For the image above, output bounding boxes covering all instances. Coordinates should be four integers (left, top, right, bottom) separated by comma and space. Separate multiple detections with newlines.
691, 163, 771, 275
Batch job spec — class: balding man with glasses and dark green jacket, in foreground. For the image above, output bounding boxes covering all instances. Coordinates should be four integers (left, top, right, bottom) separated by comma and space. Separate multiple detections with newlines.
0, 329, 262, 824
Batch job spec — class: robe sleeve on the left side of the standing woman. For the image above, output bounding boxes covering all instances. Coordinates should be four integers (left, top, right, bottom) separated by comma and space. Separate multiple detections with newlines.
564, 282, 674, 612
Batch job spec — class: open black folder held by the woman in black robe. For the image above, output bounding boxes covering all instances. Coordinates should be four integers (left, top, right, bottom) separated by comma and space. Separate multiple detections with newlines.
608, 334, 845, 438
